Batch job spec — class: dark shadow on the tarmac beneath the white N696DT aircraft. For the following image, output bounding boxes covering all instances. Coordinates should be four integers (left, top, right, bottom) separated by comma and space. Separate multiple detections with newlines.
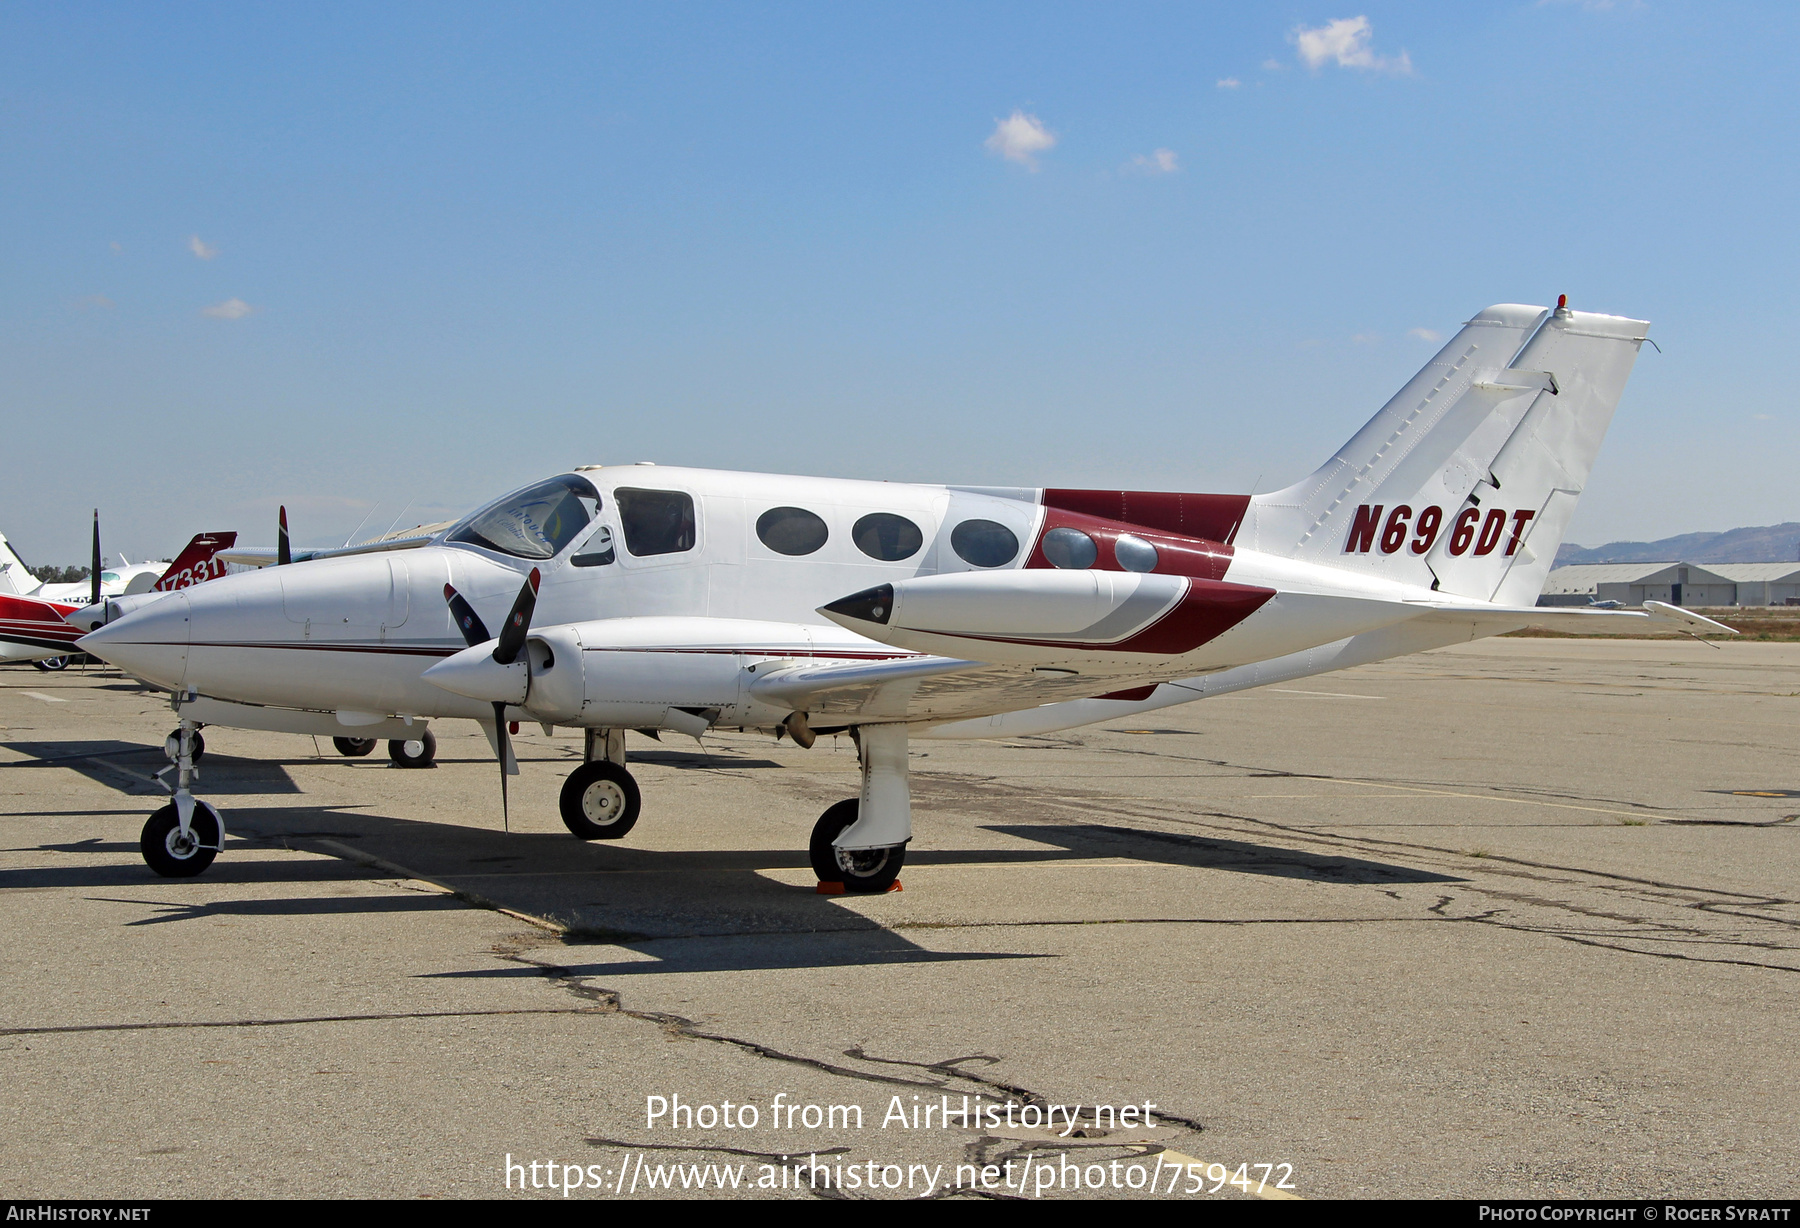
0, 788, 1456, 976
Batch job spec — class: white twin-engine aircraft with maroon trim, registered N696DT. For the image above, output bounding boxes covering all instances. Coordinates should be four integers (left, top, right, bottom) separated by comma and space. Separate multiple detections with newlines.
79, 302, 1717, 891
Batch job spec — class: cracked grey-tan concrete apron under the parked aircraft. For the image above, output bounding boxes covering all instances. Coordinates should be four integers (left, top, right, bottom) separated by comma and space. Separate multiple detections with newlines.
0, 639, 1800, 1197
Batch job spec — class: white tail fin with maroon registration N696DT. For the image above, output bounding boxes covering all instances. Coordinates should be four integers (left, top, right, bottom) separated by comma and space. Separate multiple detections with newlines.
1237, 304, 1649, 605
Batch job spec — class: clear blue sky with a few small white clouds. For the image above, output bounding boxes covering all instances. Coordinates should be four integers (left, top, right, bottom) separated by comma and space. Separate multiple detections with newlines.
0, 0, 1800, 562
